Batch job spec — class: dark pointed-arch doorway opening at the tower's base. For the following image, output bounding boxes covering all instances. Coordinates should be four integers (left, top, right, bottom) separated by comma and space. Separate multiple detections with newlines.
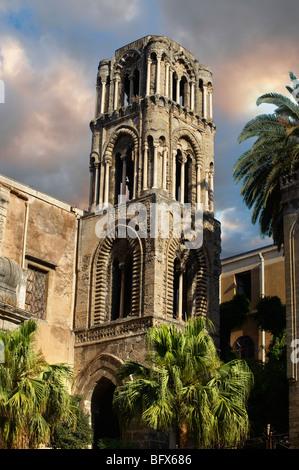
91, 377, 120, 448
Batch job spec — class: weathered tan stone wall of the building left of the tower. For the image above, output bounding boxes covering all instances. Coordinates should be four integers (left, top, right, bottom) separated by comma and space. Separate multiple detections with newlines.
0, 176, 81, 364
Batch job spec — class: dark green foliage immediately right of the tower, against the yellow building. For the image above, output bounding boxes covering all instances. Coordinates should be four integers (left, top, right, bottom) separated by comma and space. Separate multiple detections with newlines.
219, 294, 250, 360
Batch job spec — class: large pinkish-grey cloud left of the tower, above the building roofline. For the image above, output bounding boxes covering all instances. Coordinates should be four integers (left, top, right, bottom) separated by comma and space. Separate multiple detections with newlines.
0, 34, 94, 206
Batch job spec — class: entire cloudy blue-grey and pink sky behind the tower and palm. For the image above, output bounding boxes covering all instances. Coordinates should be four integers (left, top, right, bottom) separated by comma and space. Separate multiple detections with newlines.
0, 0, 299, 257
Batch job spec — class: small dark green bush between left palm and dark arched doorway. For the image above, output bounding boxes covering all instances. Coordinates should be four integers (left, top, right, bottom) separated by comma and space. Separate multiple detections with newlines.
51, 395, 93, 449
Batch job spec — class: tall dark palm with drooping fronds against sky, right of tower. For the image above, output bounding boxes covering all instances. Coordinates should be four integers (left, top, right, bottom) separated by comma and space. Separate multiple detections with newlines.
234, 72, 299, 248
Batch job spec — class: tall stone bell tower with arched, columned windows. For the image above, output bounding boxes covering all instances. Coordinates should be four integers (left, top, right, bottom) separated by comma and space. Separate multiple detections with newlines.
74, 36, 220, 448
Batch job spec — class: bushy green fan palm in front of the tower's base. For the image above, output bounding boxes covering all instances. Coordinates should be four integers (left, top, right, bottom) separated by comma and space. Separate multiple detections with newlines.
114, 317, 252, 448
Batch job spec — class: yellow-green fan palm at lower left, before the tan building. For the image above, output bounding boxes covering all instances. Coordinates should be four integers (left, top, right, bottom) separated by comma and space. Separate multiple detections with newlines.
0, 320, 73, 449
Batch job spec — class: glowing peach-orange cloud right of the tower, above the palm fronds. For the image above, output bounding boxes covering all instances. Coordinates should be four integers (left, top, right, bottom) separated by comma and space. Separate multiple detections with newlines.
214, 41, 299, 119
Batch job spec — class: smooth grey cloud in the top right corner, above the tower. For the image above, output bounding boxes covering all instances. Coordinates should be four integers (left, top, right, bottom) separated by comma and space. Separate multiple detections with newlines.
159, 0, 299, 65
